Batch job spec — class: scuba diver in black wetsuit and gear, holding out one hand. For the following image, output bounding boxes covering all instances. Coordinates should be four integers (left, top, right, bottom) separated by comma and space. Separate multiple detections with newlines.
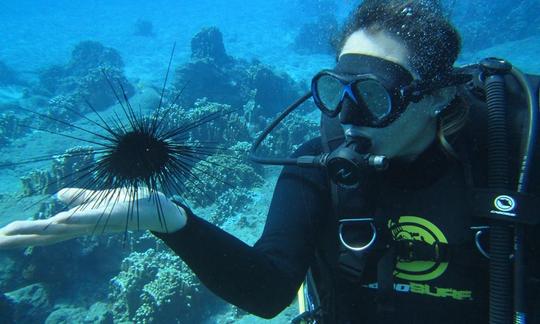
0, 0, 540, 323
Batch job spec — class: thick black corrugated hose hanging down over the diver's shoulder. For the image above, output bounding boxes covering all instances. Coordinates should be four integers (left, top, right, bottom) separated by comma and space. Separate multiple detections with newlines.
481, 58, 514, 324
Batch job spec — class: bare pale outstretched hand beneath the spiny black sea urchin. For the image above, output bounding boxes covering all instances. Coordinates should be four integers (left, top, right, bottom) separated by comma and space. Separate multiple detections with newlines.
0, 188, 186, 249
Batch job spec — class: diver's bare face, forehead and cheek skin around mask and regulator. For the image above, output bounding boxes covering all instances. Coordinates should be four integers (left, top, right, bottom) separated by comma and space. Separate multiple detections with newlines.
338, 31, 455, 160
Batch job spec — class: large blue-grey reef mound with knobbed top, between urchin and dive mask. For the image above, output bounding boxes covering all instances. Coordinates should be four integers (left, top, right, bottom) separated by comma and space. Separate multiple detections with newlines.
175, 28, 299, 116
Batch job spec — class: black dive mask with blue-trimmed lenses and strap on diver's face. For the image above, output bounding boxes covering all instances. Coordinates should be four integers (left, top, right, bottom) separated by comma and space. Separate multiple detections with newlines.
311, 54, 466, 128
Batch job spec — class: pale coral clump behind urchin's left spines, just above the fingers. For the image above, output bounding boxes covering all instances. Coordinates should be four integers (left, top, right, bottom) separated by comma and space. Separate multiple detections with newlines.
21, 146, 94, 196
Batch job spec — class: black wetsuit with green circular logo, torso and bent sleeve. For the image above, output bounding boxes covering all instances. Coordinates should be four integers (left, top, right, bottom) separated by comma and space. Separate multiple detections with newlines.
152, 135, 539, 323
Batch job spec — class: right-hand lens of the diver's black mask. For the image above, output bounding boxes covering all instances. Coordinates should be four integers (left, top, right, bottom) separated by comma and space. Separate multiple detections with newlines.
354, 80, 392, 119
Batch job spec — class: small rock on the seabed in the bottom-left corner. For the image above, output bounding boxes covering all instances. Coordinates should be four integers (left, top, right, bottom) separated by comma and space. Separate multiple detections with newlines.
6, 283, 52, 323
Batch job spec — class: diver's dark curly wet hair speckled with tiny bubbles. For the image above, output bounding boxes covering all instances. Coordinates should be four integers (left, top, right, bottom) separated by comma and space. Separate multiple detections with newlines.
336, 0, 461, 79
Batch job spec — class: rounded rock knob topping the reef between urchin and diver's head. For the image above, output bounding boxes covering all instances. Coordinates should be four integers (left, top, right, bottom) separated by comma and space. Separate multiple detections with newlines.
191, 27, 232, 66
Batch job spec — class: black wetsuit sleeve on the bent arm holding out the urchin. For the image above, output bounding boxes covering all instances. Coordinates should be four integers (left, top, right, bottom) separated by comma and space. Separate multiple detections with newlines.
154, 138, 329, 318
